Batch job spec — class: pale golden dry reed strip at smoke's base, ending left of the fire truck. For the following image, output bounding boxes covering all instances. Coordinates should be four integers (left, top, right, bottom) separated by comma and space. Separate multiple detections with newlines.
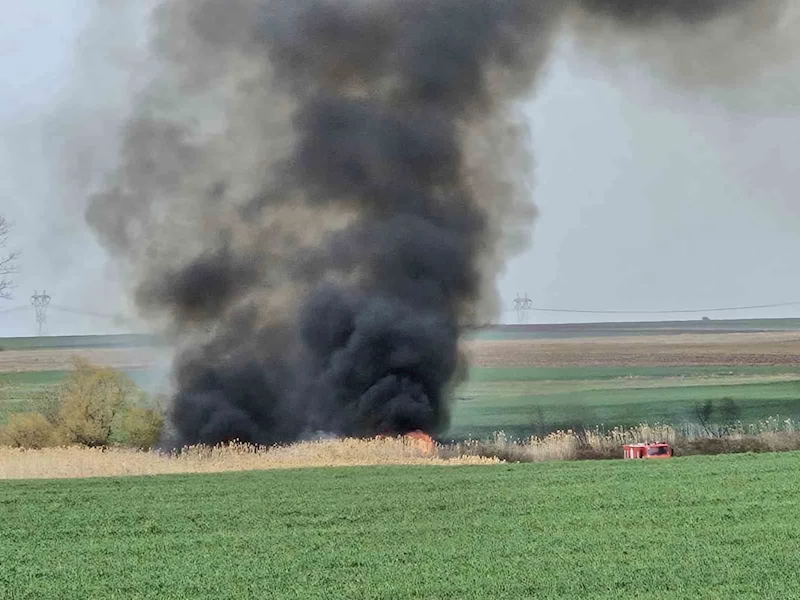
0, 438, 500, 479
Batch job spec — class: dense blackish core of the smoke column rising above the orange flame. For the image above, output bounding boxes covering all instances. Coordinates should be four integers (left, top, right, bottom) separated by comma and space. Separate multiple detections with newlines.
263, 0, 564, 435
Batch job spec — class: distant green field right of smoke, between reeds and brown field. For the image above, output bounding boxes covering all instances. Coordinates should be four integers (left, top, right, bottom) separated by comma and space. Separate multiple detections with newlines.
447, 366, 800, 438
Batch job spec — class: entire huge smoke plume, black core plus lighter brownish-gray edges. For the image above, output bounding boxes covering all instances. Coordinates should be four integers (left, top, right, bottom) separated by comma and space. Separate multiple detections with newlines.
78, 0, 792, 445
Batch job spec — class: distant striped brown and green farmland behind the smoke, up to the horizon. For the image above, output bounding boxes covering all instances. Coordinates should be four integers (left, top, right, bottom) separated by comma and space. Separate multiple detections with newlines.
0, 319, 800, 438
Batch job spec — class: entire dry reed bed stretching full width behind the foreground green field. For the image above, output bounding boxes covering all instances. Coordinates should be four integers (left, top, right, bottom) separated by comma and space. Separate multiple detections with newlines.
0, 419, 800, 479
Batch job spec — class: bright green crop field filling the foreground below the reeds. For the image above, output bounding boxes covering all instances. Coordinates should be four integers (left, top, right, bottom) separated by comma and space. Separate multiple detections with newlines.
0, 453, 800, 600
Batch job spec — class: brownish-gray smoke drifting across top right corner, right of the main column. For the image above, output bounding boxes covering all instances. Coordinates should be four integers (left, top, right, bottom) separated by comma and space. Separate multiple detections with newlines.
569, 0, 800, 89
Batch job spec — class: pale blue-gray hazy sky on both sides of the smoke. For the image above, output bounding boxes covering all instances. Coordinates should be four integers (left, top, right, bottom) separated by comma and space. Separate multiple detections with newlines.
0, 0, 800, 336
